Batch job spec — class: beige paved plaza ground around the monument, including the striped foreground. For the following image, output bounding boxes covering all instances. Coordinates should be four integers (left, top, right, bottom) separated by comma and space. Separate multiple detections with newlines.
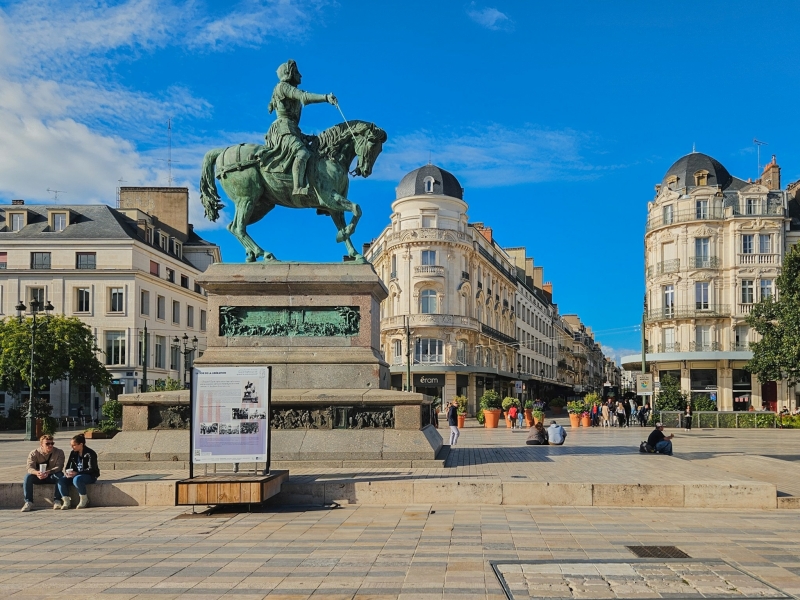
0, 427, 800, 600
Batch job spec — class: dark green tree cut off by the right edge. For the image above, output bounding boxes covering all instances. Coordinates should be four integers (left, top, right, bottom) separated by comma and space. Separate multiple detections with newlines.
745, 244, 800, 386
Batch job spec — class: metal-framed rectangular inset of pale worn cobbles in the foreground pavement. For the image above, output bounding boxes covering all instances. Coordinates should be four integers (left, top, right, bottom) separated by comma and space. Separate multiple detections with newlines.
489, 559, 792, 600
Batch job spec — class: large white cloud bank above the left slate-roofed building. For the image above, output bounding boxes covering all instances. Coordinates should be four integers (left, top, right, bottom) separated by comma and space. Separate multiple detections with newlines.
0, 0, 325, 229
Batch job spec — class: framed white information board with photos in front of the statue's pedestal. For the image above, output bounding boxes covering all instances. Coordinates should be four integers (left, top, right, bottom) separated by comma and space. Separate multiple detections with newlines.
191, 365, 272, 468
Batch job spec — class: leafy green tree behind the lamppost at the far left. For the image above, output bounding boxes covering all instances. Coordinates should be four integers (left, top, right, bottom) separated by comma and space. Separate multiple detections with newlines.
0, 315, 111, 408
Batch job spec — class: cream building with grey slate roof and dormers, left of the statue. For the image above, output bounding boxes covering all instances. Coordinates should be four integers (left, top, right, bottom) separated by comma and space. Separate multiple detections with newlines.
0, 188, 221, 416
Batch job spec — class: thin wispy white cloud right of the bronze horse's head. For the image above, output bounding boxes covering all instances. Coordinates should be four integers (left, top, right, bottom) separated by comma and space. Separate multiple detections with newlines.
373, 123, 614, 187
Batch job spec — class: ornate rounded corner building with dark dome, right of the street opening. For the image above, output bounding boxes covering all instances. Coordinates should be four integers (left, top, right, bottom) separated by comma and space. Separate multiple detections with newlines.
623, 152, 794, 410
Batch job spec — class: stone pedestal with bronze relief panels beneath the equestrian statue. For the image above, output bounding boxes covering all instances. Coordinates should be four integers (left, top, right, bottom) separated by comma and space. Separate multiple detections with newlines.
100, 263, 443, 468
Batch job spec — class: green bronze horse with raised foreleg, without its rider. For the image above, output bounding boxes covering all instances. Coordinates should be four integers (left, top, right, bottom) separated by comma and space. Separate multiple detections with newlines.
200, 121, 386, 263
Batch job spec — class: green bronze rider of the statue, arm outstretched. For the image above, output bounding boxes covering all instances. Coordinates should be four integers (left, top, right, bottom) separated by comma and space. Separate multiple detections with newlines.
258, 60, 336, 196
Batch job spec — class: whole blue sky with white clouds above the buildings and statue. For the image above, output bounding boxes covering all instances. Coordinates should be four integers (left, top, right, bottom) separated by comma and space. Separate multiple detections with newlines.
0, 0, 800, 355
